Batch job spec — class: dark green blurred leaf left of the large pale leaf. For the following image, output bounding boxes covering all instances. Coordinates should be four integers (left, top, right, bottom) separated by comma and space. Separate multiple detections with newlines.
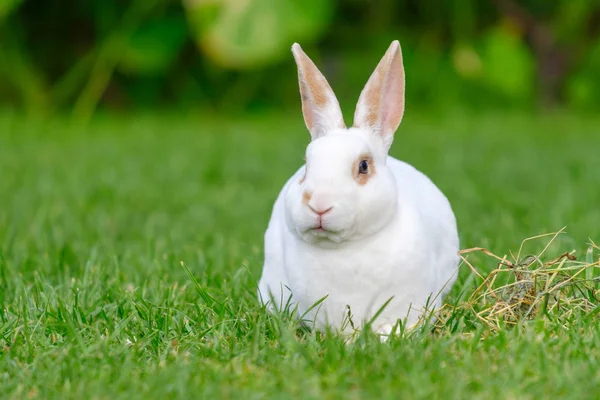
119, 18, 187, 75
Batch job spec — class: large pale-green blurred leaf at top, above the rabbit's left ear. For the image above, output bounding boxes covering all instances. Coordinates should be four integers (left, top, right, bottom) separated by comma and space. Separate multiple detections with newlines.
184, 0, 333, 69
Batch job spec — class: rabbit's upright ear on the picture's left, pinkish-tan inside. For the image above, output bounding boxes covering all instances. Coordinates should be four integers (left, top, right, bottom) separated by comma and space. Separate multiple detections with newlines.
292, 43, 346, 140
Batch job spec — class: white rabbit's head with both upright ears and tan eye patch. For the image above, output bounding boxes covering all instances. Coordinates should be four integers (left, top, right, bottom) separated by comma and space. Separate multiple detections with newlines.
285, 41, 404, 244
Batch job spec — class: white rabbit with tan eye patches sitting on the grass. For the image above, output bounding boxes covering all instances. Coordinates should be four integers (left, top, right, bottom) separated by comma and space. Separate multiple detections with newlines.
258, 41, 459, 335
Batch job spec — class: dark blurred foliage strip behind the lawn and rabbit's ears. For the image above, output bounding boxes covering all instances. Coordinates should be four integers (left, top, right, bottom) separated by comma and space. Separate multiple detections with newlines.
0, 0, 600, 120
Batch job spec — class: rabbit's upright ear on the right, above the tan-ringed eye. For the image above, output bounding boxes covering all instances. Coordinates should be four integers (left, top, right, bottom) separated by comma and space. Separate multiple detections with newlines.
354, 40, 404, 152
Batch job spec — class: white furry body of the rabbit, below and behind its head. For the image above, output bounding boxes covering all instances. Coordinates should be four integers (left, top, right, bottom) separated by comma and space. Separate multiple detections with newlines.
259, 157, 459, 334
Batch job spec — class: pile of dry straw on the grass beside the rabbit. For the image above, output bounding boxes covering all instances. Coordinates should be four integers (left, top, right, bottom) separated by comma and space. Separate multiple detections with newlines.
428, 228, 600, 333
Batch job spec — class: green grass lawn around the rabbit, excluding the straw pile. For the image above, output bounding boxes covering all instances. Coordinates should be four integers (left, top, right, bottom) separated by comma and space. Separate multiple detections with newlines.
0, 108, 600, 400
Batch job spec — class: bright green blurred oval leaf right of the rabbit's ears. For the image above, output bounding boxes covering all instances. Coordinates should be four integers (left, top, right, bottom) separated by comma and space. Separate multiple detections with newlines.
481, 25, 535, 99
